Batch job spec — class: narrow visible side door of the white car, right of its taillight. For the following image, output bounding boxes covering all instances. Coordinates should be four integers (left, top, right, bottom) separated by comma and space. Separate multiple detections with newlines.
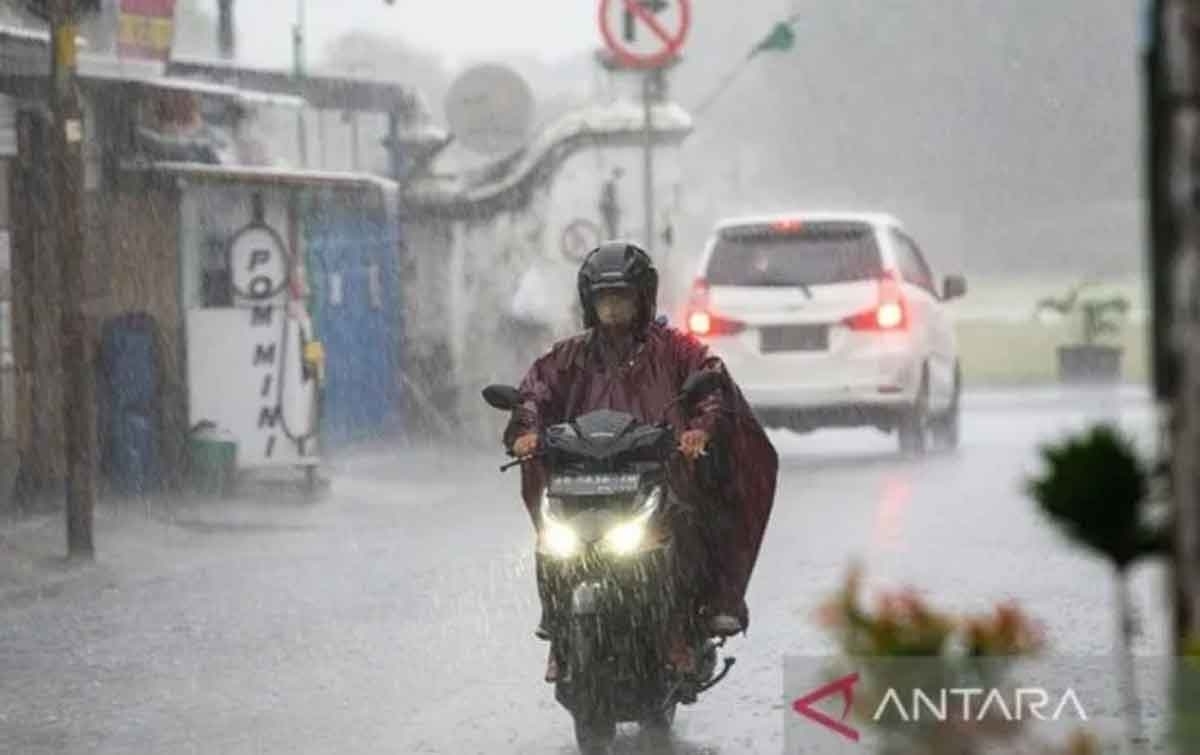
892, 228, 954, 409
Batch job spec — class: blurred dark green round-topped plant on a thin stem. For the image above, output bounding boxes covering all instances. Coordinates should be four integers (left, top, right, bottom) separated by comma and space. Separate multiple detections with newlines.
1026, 425, 1170, 753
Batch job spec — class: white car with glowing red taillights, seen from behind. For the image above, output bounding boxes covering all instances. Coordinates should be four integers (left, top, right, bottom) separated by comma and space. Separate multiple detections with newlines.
684, 214, 966, 454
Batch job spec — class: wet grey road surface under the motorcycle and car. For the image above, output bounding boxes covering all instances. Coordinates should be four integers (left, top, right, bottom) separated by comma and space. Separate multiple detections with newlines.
0, 393, 1165, 755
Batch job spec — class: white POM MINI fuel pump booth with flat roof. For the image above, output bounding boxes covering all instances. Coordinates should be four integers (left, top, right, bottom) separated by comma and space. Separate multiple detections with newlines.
142, 163, 396, 484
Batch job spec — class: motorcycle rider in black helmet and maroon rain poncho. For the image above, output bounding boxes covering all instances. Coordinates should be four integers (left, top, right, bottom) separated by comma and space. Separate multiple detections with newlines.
504, 241, 779, 681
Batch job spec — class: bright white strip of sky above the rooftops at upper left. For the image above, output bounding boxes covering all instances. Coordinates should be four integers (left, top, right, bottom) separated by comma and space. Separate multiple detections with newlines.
228, 0, 600, 68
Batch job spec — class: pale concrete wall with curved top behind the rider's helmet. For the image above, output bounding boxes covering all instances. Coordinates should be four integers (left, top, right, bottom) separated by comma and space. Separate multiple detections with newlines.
436, 141, 685, 438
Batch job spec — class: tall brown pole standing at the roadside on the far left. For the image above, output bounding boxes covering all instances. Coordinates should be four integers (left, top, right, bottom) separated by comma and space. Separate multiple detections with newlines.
50, 0, 96, 559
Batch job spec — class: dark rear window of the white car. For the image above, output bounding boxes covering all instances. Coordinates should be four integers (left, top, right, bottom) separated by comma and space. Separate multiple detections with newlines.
706, 222, 883, 286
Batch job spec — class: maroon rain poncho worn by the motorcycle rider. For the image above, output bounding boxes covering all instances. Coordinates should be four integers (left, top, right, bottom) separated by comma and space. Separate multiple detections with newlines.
504, 323, 779, 627
